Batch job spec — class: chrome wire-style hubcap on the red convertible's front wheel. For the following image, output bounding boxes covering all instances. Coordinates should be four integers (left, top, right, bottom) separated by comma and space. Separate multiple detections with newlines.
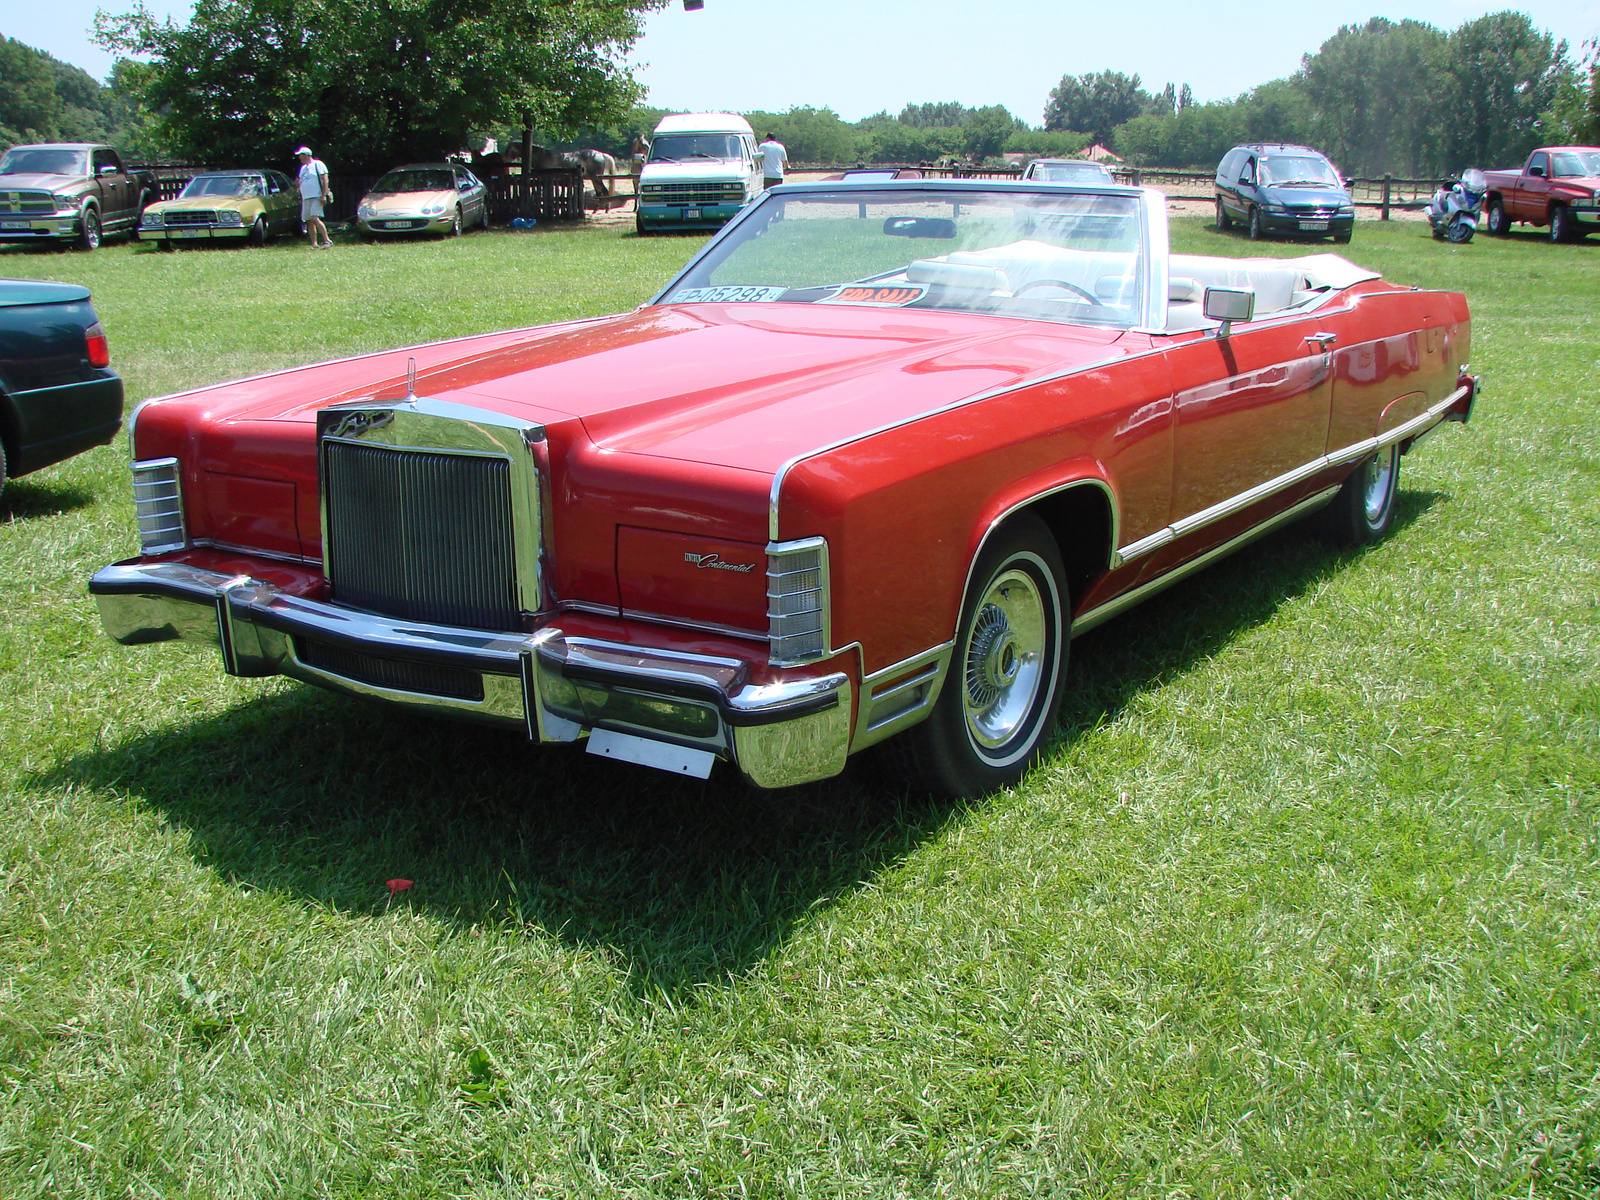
963, 570, 1048, 749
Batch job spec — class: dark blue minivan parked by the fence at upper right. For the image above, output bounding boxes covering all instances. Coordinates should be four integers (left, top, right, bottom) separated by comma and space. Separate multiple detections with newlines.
1216, 142, 1355, 242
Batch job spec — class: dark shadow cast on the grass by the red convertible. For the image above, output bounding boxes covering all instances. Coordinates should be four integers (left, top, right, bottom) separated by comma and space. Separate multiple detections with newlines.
32, 493, 1440, 998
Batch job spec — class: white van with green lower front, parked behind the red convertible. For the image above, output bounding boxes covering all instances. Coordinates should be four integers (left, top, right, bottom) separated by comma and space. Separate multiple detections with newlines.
635, 112, 762, 234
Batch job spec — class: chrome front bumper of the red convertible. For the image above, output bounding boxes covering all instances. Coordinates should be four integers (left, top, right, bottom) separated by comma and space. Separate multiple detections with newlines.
90, 560, 853, 787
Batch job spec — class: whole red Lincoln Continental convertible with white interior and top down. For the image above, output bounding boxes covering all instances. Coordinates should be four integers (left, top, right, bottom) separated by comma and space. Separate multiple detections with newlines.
90, 181, 1477, 795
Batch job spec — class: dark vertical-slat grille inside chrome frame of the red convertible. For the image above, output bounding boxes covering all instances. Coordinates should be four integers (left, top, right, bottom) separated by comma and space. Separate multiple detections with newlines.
323, 438, 522, 630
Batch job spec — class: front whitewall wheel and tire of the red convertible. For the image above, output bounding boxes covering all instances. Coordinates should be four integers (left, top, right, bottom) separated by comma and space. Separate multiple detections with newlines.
883, 517, 1070, 797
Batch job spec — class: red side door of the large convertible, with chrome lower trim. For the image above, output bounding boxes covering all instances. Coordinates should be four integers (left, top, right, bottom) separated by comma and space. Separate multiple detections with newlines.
1168, 310, 1338, 557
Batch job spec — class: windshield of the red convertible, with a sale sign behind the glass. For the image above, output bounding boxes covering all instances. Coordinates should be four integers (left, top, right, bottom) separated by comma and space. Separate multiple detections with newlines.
664, 189, 1146, 326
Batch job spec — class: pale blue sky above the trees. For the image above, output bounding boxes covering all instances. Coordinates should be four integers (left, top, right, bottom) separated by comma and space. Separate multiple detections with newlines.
12, 0, 1600, 125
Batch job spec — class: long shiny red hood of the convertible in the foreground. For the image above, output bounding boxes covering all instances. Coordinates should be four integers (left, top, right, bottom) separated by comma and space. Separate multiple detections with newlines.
174, 304, 1136, 474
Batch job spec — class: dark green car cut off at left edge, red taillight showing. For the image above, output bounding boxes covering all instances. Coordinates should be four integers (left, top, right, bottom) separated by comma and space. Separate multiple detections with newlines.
0, 278, 122, 486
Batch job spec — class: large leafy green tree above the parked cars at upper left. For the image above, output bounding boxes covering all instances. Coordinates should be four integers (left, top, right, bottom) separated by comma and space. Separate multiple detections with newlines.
96, 0, 666, 171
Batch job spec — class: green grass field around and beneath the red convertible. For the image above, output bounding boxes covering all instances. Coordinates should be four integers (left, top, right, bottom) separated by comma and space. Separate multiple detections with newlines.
0, 219, 1600, 1200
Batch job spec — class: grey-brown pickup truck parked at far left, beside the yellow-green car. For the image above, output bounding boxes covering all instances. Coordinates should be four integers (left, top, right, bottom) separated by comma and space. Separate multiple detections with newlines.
0, 142, 158, 250
